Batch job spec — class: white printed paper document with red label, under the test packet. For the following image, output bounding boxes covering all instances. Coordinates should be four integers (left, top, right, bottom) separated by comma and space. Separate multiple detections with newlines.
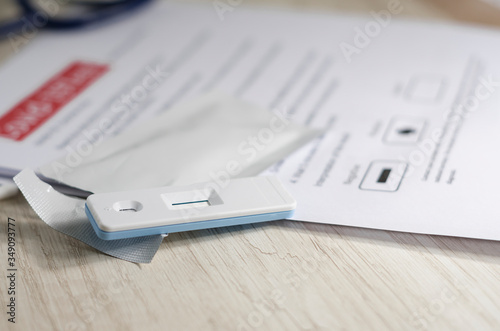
0, 3, 500, 240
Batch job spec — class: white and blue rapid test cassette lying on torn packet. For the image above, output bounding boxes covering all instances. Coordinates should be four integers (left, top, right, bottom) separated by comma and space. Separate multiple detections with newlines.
85, 177, 296, 240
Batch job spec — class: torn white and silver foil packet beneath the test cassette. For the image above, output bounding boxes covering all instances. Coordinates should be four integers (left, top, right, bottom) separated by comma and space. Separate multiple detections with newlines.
16, 93, 319, 263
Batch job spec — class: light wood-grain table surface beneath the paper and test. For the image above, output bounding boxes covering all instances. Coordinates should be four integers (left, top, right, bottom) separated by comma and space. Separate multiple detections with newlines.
0, 0, 500, 330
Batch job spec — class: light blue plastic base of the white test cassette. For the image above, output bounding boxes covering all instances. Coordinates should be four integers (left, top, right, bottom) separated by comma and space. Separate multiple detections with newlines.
85, 204, 295, 240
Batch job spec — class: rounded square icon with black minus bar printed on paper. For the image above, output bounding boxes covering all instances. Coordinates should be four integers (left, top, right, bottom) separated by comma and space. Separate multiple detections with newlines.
359, 161, 408, 192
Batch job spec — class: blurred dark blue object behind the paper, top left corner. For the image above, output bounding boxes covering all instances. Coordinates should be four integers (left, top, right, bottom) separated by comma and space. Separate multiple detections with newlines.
0, 0, 152, 39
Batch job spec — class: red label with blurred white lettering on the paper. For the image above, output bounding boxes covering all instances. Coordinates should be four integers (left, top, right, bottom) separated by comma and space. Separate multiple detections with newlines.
0, 62, 109, 141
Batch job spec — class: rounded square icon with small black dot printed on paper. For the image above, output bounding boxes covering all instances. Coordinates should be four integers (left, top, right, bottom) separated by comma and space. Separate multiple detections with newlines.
384, 117, 426, 144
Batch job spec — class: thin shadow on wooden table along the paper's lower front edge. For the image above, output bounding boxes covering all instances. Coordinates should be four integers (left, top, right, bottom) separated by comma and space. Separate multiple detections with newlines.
160, 220, 500, 264
